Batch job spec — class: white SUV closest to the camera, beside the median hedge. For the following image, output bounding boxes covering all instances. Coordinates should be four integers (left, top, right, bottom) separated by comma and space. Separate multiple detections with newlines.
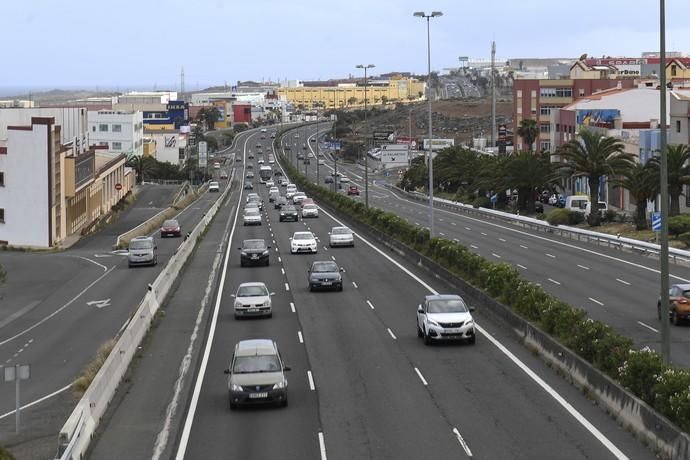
417, 294, 476, 345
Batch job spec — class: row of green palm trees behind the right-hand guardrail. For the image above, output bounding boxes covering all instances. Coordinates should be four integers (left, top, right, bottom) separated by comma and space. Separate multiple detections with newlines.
401, 126, 690, 230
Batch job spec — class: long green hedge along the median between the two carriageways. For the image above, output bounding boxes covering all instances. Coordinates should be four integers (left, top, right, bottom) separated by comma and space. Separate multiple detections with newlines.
282, 156, 690, 450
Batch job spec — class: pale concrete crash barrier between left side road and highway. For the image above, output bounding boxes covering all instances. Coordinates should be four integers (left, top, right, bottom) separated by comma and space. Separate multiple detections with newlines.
56, 169, 235, 460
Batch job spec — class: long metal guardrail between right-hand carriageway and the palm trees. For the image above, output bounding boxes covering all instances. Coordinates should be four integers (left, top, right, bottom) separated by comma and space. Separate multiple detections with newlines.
385, 184, 690, 266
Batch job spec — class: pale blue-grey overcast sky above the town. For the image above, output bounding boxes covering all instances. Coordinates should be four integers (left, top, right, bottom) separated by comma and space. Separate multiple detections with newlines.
0, 0, 690, 90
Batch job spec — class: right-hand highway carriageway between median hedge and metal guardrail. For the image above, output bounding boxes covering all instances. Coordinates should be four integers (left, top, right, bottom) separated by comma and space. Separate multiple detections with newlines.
292, 122, 690, 367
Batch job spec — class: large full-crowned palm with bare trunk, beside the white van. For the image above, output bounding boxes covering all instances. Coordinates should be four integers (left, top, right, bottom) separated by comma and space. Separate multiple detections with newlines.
556, 129, 634, 227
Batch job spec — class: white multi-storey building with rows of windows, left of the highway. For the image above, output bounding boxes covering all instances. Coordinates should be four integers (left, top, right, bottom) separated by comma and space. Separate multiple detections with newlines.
88, 110, 144, 156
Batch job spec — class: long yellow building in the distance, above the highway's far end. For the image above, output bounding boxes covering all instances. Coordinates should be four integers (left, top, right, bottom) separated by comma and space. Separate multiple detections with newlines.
278, 78, 425, 109
